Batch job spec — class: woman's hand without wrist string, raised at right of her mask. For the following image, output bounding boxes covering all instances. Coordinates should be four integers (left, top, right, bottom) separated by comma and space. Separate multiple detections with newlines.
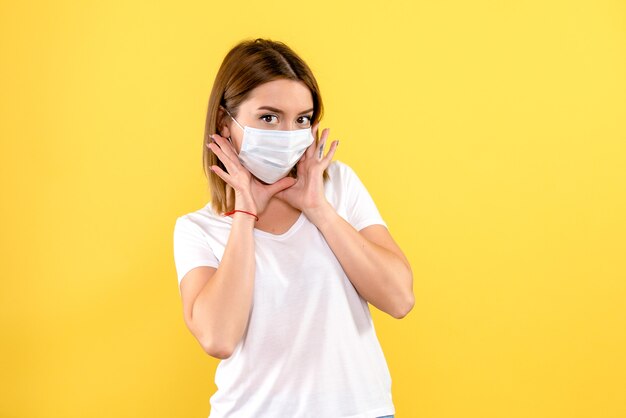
275, 122, 339, 224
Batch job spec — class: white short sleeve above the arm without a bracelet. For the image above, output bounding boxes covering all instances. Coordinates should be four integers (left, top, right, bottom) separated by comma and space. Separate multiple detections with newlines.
339, 163, 387, 231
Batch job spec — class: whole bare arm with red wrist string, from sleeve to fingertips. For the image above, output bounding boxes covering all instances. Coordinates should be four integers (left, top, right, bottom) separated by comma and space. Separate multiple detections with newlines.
181, 134, 295, 359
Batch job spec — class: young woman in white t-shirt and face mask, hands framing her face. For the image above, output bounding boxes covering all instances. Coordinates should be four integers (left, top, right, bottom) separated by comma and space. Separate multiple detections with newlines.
174, 39, 414, 418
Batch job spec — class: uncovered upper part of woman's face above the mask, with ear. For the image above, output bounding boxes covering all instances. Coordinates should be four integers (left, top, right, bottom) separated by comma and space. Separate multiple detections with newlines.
222, 79, 313, 152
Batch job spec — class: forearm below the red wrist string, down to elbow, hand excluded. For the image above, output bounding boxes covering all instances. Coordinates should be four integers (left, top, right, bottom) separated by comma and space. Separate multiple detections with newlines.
192, 212, 255, 357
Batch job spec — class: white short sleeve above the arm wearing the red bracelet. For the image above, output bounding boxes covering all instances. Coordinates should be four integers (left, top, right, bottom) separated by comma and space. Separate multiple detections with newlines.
174, 216, 219, 287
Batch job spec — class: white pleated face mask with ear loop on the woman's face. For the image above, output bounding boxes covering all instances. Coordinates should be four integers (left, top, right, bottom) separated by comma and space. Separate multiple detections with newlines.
226, 111, 315, 184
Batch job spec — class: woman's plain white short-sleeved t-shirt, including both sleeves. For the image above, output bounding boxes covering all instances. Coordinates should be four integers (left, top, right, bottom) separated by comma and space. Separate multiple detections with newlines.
174, 161, 395, 418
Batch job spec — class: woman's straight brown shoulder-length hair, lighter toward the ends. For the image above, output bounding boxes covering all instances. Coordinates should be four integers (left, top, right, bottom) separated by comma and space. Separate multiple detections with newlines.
202, 38, 328, 213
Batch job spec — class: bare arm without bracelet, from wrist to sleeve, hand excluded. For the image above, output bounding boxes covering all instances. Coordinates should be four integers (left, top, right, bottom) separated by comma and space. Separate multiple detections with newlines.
307, 203, 415, 319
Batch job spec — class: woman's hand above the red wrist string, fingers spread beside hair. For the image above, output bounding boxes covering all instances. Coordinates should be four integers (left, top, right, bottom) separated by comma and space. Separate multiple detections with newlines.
207, 134, 296, 215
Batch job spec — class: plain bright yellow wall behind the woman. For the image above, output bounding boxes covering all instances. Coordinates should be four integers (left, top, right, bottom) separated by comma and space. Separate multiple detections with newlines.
0, 0, 626, 418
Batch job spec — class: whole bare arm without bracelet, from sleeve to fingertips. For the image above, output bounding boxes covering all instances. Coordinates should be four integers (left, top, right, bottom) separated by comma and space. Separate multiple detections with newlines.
276, 123, 414, 318
